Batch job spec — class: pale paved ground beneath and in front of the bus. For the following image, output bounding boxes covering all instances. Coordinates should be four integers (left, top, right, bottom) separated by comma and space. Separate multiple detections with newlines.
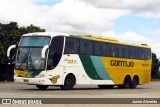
0, 82, 160, 107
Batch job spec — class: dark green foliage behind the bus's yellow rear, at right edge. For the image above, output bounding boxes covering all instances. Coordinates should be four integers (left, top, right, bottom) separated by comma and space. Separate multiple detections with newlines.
151, 53, 160, 78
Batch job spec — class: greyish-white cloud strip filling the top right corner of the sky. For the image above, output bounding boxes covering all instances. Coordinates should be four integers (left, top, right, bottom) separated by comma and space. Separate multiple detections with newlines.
83, 0, 160, 17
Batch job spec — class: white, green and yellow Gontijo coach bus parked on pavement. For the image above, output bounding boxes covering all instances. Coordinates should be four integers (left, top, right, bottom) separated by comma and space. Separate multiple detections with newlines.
7, 32, 152, 90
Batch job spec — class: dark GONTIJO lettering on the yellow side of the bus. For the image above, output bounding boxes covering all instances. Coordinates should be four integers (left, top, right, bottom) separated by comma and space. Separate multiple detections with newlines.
110, 60, 134, 67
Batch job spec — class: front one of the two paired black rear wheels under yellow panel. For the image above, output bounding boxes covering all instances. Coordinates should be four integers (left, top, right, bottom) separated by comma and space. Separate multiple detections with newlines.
118, 75, 131, 89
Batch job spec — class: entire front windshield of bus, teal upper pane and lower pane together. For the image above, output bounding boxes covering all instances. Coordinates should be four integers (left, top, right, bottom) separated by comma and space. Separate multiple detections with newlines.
15, 36, 50, 71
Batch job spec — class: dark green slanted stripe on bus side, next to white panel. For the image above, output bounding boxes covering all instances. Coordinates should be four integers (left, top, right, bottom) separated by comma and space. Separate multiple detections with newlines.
79, 55, 102, 80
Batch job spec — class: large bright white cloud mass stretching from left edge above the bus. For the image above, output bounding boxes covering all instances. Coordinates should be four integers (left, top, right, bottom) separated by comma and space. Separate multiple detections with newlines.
0, 0, 126, 33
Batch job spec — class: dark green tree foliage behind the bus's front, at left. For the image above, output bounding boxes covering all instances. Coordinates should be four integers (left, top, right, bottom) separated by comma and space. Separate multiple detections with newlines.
0, 22, 45, 64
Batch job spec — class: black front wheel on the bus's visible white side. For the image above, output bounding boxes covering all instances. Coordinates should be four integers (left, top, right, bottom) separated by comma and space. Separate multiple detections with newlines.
60, 74, 75, 90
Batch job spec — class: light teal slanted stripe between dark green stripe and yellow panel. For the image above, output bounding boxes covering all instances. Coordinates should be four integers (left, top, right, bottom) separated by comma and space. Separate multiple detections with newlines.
91, 56, 111, 80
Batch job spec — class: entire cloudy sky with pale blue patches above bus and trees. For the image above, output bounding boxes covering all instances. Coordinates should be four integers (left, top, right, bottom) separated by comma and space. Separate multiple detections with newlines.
0, 0, 160, 58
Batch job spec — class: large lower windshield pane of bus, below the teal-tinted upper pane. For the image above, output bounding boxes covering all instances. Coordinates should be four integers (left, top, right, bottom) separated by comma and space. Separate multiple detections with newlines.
16, 47, 45, 70
